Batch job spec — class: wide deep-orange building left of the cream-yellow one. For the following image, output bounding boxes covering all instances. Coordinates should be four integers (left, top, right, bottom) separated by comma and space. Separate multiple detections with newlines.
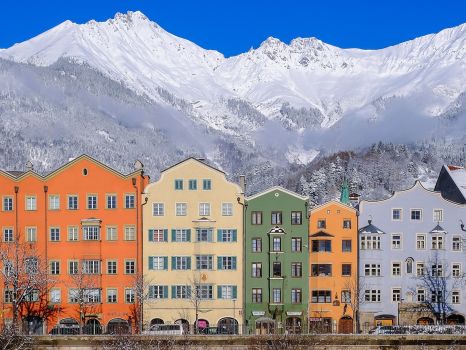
0, 155, 149, 334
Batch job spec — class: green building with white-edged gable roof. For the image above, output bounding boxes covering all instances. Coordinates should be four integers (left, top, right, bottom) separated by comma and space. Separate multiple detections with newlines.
244, 187, 309, 334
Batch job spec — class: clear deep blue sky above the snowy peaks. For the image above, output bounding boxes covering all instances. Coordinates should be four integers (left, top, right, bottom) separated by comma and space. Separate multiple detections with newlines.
0, 0, 466, 56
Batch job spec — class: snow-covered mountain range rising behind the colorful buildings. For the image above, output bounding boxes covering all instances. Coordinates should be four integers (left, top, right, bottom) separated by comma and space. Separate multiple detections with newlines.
0, 12, 466, 198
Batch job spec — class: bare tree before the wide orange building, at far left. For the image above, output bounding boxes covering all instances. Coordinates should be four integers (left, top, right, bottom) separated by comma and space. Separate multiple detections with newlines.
0, 232, 58, 332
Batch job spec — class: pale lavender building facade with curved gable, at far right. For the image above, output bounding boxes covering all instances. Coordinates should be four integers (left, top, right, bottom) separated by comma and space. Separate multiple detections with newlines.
359, 182, 466, 330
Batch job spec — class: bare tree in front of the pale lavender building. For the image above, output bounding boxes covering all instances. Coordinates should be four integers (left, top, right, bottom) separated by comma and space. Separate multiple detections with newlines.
415, 254, 466, 325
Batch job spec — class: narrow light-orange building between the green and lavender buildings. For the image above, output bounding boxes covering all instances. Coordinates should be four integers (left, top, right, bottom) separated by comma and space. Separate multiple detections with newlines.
309, 201, 358, 333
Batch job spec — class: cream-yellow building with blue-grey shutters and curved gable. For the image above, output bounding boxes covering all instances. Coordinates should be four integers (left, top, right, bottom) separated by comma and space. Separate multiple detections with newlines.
143, 158, 244, 333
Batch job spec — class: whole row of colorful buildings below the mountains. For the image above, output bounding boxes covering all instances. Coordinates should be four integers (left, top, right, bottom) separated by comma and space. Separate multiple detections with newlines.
0, 155, 466, 333
